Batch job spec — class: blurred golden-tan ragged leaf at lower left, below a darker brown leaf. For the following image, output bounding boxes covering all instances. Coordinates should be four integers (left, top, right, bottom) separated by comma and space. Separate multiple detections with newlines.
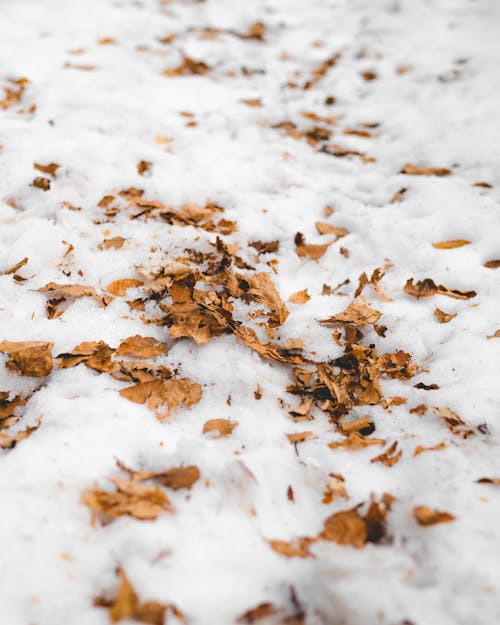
82, 477, 173, 524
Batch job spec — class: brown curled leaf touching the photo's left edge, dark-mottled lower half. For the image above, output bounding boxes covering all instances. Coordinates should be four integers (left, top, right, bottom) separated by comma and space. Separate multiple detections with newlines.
0, 341, 54, 378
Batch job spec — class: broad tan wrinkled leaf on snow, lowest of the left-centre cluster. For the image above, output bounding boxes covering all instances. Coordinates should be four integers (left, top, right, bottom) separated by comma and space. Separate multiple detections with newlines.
120, 378, 201, 416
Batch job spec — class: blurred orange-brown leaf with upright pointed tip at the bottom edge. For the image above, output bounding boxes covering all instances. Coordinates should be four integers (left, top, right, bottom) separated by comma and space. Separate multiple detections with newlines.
94, 567, 169, 625
